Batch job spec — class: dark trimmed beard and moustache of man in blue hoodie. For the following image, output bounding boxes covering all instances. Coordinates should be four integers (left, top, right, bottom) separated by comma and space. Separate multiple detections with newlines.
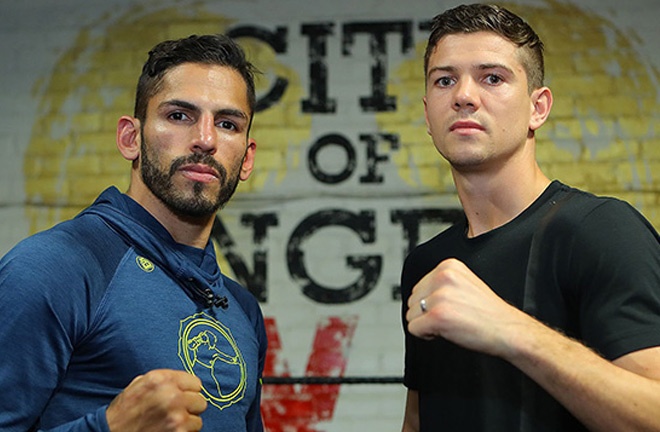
140, 135, 240, 218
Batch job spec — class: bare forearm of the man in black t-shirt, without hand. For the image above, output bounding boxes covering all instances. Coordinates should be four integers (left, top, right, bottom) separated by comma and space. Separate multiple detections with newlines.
505, 320, 660, 432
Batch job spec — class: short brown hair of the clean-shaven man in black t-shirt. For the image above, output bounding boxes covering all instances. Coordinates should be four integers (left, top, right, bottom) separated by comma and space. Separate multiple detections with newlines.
424, 3, 545, 92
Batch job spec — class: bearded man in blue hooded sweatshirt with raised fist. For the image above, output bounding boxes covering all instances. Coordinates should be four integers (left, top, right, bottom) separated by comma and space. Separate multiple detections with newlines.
0, 35, 266, 432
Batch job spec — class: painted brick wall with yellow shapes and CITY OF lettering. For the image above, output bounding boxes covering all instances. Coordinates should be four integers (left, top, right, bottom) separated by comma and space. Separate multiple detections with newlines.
0, 0, 660, 431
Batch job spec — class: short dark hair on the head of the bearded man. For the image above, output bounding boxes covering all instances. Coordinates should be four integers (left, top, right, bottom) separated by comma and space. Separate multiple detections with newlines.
133, 34, 258, 122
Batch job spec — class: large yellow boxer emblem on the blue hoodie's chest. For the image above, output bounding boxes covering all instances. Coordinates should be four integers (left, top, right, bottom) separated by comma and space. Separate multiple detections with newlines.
179, 312, 247, 410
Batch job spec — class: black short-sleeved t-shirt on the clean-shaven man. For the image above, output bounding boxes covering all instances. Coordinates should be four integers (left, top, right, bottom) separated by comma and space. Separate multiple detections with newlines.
401, 181, 660, 432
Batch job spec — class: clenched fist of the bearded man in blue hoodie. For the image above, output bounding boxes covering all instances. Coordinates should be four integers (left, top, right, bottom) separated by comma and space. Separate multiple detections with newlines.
106, 369, 207, 432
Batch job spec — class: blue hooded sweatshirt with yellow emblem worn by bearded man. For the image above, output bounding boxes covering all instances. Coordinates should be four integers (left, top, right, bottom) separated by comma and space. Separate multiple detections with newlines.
0, 187, 267, 432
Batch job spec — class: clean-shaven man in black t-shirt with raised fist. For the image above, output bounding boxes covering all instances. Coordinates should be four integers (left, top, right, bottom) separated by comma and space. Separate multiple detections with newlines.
401, 4, 660, 432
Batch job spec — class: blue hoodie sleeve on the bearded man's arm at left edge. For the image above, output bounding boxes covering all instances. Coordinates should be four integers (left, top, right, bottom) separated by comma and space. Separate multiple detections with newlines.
0, 230, 108, 431
